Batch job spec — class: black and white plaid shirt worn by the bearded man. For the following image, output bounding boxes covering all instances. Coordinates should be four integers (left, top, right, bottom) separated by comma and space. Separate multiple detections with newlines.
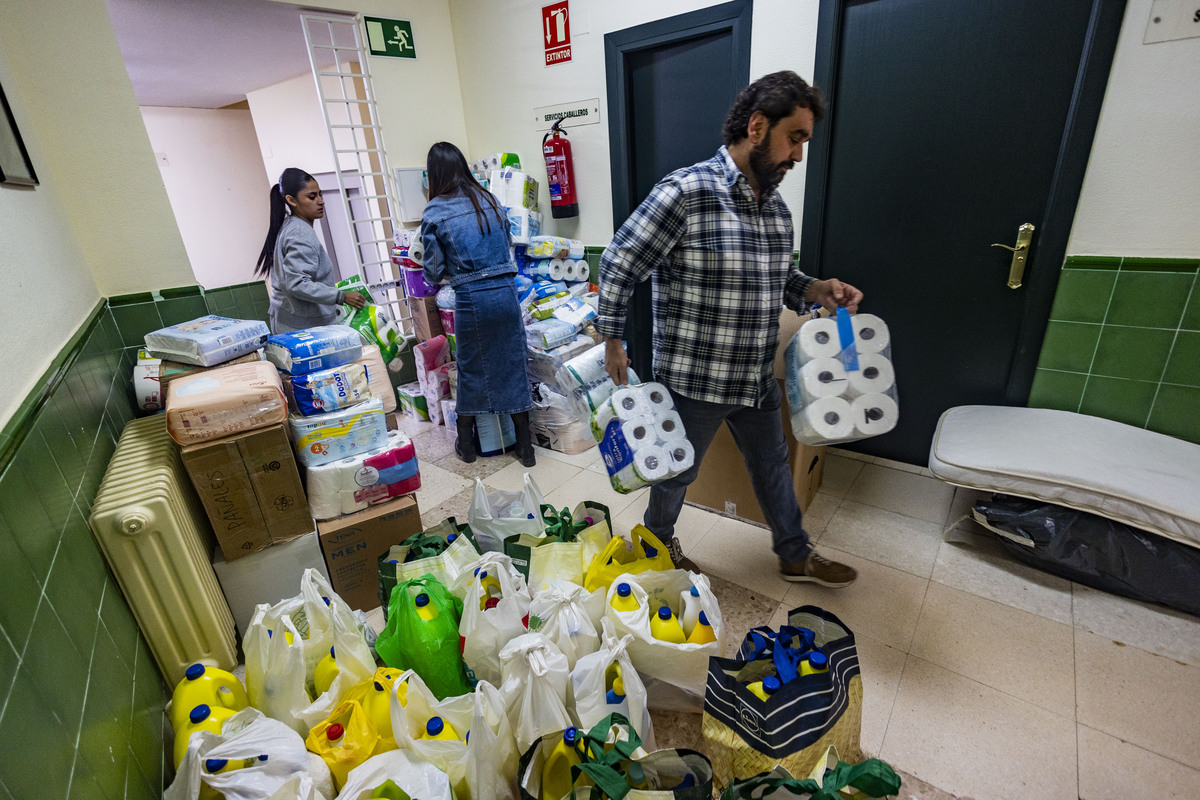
595, 146, 814, 405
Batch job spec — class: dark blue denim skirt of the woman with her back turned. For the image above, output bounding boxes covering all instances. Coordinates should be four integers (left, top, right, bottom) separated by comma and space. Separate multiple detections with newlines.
454, 275, 533, 416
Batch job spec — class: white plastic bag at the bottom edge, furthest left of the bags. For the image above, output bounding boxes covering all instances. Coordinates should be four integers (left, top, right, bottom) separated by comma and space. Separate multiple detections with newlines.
163, 708, 334, 800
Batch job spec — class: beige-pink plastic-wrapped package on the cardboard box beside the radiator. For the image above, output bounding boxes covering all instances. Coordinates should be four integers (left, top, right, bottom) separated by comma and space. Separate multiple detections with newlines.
167, 361, 288, 445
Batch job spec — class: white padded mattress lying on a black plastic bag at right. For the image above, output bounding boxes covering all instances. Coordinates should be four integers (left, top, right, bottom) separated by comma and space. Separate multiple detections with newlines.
929, 405, 1200, 547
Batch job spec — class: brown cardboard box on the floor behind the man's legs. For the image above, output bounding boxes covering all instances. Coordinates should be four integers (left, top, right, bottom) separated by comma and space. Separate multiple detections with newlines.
686, 386, 826, 525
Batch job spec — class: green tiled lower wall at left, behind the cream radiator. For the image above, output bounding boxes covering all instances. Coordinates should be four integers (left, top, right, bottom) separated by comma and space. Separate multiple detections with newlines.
0, 283, 268, 800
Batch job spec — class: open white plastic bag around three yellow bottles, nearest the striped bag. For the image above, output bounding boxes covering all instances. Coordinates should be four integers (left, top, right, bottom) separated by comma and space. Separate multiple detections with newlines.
605, 570, 725, 712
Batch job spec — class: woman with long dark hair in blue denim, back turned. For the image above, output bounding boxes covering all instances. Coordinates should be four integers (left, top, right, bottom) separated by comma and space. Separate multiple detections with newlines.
421, 142, 534, 467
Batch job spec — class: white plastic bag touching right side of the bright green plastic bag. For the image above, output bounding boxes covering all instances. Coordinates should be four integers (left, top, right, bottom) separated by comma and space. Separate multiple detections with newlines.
450, 553, 530, 686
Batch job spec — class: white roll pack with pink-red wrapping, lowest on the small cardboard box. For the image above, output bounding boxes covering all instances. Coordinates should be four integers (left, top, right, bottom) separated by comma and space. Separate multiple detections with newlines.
305, 431, 421, 519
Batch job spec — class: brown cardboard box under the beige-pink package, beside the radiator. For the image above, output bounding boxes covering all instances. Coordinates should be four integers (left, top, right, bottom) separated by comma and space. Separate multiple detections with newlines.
181, 425, 312, 561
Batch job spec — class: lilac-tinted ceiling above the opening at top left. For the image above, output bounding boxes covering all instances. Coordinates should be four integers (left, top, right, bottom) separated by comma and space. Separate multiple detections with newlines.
106, 0, 348, 108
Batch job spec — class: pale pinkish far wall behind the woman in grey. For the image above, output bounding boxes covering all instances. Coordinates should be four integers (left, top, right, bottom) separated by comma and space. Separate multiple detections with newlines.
142, 107, 270, 289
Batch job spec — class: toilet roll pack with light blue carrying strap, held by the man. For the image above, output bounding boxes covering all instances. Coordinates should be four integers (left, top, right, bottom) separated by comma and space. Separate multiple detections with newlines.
784, 308, 900, 445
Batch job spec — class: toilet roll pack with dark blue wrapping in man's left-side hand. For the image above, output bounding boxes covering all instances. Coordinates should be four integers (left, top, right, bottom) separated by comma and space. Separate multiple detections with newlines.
592, 383, 696, 494
